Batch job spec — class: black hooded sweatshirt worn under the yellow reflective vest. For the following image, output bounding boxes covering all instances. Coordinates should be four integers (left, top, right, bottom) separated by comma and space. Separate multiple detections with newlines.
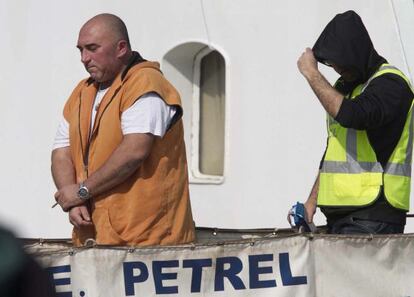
312, 11, 413, 225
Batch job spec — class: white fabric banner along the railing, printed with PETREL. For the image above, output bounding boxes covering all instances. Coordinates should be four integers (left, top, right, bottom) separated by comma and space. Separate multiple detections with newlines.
27, 235, 414, 297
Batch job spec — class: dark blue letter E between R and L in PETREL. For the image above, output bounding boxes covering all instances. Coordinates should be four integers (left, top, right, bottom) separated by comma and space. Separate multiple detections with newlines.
249, 254, 276, 289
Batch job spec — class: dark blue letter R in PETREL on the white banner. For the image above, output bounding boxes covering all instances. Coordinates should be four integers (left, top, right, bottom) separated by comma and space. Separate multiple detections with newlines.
214, 257, 246, 291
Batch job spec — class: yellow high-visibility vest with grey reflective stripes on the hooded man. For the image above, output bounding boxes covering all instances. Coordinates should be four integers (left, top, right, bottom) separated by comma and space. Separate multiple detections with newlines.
318, 64, 414, 211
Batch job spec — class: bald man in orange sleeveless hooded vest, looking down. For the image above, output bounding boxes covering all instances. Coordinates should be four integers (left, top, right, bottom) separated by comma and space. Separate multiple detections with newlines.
52, 14, 195, 246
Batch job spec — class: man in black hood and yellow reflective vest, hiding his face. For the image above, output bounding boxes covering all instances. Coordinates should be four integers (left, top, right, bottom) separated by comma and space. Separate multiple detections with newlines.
297, 11, 414, 234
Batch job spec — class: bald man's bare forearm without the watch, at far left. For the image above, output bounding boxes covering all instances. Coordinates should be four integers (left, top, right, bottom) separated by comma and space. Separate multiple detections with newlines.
51, 147, 76, 189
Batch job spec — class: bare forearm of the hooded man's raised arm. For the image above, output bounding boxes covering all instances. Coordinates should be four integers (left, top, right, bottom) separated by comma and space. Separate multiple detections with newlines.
305, 70, 344, 118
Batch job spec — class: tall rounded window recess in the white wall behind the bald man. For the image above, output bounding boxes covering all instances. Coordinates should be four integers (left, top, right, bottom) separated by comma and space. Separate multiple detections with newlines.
161, 42, 227, 184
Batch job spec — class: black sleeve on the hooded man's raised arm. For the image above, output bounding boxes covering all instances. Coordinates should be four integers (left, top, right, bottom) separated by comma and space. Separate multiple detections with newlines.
335, 73, 413, 130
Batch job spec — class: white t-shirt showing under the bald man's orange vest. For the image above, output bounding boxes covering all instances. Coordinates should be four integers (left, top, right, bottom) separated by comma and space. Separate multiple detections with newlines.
53, 89, 177, 149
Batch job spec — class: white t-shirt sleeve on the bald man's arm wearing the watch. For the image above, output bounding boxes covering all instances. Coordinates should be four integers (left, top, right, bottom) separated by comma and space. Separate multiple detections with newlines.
121, 93, 177, 137
